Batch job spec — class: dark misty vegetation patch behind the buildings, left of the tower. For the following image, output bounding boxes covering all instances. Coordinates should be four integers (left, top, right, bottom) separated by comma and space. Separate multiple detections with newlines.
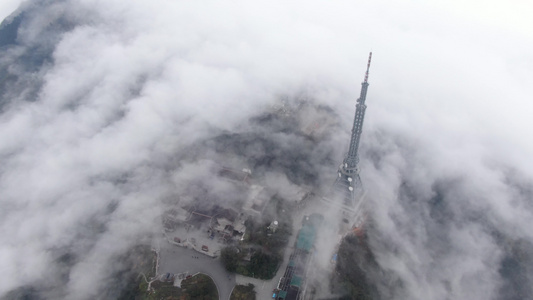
175, 100, 337, 186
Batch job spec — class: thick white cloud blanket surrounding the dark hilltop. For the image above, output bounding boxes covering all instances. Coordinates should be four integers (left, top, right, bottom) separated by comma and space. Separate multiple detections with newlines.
0, 0, 533, 299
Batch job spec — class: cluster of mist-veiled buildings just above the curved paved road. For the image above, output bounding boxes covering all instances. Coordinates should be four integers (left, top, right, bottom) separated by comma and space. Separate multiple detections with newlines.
162, 167, 308, 257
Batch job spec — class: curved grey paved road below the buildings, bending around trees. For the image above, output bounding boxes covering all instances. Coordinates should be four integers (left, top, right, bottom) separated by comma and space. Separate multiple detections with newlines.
159, 241, 235, 300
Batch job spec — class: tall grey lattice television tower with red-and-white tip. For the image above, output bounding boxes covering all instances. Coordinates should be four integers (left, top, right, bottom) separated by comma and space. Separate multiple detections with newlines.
333, 52, 372, 218
